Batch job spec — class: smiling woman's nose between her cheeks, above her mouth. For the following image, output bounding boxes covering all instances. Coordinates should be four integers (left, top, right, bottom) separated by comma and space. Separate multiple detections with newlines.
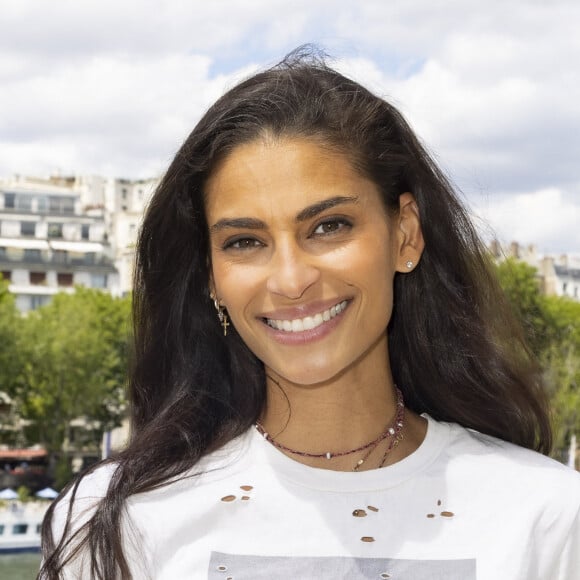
266, 244, 320, 300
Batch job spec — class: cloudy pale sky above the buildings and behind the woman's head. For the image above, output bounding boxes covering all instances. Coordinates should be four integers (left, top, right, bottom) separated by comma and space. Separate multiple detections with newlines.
0, 0, 580, 253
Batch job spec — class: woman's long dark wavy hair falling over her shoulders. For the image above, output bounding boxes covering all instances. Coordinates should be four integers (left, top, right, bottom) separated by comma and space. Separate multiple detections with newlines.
39, 49, 551, 580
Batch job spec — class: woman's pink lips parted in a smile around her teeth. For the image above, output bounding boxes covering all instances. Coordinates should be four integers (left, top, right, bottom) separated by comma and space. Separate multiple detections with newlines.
259, 298, 352, 345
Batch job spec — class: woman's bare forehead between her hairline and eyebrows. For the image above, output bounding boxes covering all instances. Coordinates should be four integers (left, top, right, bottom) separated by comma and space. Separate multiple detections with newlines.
205, 138, 379, 225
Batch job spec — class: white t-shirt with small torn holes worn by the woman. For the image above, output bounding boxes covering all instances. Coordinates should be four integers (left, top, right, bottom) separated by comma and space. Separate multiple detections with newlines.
55, 417, 580, 580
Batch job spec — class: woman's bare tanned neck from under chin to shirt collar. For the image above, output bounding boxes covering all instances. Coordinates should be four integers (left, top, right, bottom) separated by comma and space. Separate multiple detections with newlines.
260, 336, 425, 471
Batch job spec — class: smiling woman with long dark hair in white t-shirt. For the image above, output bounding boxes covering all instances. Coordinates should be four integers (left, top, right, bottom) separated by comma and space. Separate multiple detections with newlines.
40, 52, 580, 580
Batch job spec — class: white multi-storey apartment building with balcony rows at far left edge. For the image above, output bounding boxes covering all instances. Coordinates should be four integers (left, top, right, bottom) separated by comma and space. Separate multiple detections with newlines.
0, 178, 120, 312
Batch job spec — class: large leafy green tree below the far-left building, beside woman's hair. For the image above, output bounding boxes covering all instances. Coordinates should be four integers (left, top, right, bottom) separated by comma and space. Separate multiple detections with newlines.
19, 287, 130, 468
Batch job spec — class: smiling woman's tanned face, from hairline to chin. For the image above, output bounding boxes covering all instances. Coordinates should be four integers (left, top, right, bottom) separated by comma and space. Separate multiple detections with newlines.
205, 138, 420, 385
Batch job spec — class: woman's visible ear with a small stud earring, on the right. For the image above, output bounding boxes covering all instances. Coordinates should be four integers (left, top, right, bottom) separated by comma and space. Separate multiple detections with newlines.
395, 192, 425, 273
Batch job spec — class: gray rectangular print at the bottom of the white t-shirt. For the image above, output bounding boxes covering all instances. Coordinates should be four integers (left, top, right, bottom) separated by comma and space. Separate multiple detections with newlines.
208, 552, 476, 580
